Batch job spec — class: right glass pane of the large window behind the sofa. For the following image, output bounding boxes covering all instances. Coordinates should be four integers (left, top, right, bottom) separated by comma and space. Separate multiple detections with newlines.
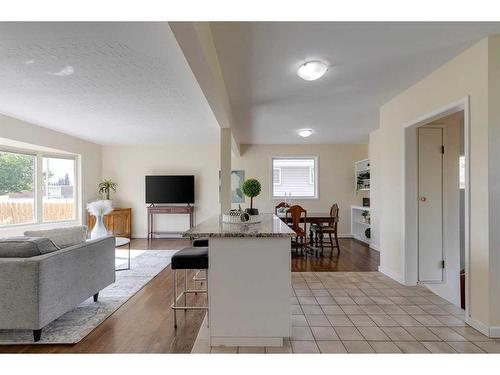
42, 157, 75, 221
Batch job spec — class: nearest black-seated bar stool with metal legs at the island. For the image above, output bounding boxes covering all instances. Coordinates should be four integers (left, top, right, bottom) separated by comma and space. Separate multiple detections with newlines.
170, 247, 208, 328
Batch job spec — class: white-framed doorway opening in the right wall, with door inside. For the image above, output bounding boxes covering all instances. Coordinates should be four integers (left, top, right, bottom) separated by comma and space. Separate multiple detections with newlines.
402, 98, 469, 316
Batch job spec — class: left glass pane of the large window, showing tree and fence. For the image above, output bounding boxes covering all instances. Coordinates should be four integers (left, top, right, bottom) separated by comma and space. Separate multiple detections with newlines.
0, 151, 36, 226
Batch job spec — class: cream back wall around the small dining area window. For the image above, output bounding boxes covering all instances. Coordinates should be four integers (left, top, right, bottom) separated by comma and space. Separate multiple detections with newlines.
232, 144, 368, 235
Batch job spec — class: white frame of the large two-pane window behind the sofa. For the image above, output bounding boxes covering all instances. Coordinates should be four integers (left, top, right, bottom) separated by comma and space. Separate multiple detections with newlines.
0, 145, 81, 229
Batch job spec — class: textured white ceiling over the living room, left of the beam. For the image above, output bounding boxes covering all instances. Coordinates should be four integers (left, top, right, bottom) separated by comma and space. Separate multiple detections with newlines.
0, 22, 219, 144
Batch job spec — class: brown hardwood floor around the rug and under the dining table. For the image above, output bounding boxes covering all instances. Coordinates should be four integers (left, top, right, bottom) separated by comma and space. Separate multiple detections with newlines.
0, 239, 379, 353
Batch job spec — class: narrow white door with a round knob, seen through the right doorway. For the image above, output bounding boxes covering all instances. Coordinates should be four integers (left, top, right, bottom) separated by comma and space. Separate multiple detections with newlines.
418, 127, 444, 282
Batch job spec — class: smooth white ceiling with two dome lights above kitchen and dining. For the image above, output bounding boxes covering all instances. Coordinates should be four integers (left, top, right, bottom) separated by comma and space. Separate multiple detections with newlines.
212, 22, 500, 144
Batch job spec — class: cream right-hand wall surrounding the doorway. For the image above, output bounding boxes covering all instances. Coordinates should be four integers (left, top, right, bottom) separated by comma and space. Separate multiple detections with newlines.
374, 39, 498, 332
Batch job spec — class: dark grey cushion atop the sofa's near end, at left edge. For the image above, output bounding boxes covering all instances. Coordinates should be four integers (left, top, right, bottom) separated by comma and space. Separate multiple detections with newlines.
0, 237, 59, 258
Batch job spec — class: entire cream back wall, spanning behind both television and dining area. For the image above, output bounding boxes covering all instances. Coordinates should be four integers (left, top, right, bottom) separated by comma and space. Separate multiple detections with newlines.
103, 145, 368, 237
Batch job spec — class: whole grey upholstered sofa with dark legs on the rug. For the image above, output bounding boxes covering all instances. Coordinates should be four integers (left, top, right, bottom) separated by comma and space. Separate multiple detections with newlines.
0, 227, 115, 341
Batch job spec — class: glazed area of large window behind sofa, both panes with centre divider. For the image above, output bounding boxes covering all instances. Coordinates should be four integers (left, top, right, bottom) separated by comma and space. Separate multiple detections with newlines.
0, 150, 77, 227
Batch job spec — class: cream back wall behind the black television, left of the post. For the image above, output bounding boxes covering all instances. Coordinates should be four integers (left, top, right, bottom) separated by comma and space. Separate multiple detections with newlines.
102, 144, 220, 238
